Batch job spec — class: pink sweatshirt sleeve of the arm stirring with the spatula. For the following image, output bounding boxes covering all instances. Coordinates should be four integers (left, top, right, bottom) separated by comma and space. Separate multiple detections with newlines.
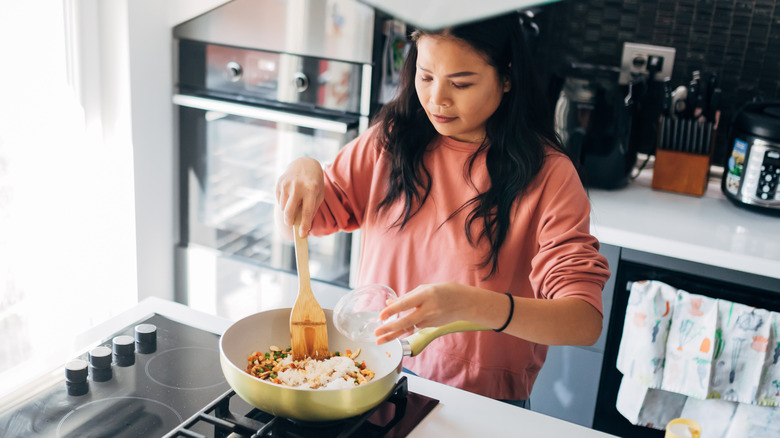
312, 126, 381, 236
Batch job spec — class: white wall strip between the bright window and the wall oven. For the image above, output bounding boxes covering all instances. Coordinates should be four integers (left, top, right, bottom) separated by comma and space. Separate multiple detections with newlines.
122, 0, 226, 300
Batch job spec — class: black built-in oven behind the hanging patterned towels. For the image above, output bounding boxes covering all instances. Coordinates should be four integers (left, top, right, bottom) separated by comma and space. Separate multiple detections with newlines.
593, 248, 780, 438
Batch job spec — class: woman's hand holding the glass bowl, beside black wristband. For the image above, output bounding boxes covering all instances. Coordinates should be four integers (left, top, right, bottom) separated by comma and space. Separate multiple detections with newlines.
374, 283, 493, 344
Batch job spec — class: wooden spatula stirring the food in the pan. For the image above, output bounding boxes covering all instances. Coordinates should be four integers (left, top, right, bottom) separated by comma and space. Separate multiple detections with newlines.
290, 214, 328, 360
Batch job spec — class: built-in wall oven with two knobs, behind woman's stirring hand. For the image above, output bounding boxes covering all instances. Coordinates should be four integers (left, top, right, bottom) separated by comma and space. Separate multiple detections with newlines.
173, 41, 362, 284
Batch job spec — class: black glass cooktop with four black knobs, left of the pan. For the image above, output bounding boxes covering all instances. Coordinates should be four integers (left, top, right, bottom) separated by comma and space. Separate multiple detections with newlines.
0, 314, 229, 438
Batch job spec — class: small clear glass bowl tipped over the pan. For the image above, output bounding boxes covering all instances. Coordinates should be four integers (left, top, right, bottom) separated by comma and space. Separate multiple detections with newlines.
333, 284, 398, 341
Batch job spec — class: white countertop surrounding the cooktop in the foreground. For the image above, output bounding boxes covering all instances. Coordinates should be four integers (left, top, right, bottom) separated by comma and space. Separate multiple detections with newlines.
0, 298, 612, 438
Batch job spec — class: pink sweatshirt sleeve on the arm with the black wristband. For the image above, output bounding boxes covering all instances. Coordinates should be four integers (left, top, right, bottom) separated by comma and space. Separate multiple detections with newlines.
530, 154, 610, 313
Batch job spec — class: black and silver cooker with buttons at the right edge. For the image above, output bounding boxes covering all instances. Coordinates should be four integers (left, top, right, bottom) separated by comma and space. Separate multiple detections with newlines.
721, 101, 780, 215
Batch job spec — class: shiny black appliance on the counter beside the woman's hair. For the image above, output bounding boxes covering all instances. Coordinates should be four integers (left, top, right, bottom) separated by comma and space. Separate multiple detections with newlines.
552, 64, 644, 189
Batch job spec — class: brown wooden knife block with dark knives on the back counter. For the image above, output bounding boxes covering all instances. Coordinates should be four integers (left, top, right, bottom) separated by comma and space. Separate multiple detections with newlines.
652, 117, 717, 196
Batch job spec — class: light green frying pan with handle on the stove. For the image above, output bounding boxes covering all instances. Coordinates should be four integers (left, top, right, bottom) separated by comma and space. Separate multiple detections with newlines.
219, 309, 488, 421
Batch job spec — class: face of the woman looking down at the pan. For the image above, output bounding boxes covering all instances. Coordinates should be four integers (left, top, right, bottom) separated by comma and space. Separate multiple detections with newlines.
414, 35, 510, 143
